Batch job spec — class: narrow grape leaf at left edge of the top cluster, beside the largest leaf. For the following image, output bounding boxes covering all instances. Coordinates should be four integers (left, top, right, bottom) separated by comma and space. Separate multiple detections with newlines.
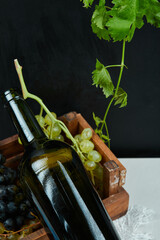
91, 3, 110, 41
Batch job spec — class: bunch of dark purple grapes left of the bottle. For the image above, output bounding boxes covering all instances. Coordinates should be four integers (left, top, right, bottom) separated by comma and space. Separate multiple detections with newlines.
0, 154, 35, 231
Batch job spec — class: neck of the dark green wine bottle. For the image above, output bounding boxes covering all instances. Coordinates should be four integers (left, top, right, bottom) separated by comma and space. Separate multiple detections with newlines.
3, 89, 47, 147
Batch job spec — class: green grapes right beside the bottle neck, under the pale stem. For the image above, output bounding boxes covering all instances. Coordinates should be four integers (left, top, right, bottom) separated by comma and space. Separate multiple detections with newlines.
35, 112, 64, 141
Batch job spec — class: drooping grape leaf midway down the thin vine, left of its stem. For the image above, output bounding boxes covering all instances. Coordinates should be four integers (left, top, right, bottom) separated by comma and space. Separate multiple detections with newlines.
92, 59, 114, 98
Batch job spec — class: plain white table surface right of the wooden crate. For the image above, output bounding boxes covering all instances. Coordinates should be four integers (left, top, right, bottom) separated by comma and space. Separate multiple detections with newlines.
119, 158, 160, 240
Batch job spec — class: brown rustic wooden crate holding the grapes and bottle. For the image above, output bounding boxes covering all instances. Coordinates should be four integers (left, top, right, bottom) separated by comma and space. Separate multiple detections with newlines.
0, 112, 129, 240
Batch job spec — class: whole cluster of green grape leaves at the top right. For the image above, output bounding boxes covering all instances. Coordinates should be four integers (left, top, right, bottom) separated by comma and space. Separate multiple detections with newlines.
84, 0, 160, 42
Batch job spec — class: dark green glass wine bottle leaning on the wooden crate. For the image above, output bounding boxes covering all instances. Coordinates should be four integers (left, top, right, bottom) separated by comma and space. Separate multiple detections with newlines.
3, 89, 120, 240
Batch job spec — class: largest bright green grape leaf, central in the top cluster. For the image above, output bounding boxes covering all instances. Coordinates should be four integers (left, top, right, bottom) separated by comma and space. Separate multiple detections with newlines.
106, 0, 144, 41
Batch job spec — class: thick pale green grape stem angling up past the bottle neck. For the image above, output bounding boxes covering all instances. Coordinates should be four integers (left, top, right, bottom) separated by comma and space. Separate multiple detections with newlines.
14, 59, 85, 162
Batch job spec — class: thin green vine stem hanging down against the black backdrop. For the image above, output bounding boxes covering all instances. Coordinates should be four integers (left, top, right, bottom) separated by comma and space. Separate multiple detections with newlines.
100, 40, 126, 148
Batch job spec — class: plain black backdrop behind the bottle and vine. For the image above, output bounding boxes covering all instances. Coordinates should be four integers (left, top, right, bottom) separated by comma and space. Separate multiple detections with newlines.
0, 0, 160, 157
